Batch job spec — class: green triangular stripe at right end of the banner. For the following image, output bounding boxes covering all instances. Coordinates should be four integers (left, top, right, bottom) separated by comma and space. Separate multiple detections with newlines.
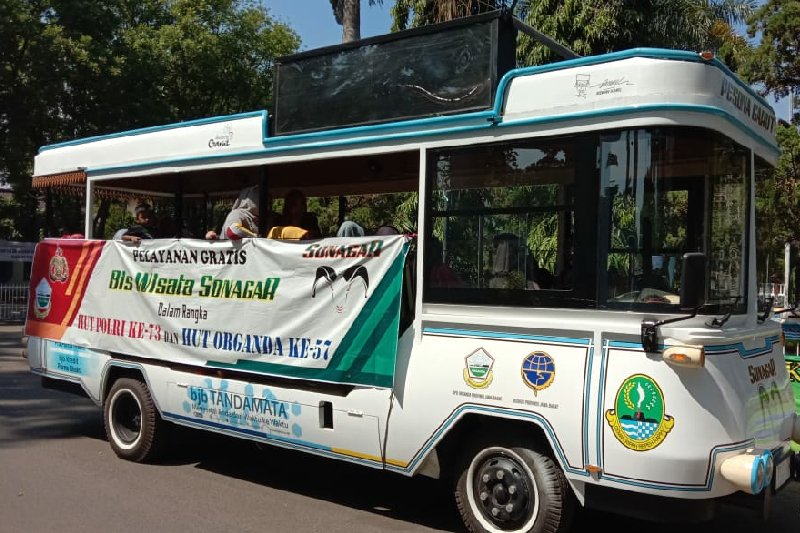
206, 245, 408, 388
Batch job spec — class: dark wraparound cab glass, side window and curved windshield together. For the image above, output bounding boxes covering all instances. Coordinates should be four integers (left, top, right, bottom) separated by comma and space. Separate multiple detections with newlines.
425, 128, 750, 313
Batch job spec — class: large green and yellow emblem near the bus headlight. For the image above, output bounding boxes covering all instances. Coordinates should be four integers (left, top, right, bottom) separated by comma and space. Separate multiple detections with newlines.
606, 374, 675, 452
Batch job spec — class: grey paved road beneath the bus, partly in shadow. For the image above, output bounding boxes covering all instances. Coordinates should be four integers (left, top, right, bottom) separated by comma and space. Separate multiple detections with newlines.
0, 326, 800, 533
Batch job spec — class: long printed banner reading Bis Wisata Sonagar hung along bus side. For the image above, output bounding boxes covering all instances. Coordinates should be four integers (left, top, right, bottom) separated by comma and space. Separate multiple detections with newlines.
27, 236, 406, 386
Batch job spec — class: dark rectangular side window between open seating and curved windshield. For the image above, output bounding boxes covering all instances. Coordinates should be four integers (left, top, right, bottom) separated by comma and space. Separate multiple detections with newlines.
424, 138, 594, 307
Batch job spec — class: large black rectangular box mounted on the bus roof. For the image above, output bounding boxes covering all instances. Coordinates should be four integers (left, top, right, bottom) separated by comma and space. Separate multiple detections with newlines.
271, 11, 516, 135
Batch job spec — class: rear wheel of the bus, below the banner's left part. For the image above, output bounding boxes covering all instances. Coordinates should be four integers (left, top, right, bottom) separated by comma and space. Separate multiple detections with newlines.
103, 378, 164, 463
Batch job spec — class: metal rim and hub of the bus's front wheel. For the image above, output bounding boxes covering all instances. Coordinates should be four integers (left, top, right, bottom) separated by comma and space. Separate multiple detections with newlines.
474, 457, 531, 528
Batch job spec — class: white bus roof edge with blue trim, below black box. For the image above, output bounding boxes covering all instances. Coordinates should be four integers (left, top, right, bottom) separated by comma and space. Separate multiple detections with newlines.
33, 48, 778, 192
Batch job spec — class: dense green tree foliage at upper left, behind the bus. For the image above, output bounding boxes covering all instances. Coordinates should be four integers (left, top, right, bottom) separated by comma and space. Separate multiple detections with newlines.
0, 0, 299, 238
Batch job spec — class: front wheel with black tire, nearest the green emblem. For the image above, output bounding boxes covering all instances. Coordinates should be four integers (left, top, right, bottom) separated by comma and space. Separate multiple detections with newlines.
455, 445, 575, 533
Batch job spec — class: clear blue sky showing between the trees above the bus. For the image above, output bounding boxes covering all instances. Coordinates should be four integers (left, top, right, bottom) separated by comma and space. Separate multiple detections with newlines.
262, 0, 789, 120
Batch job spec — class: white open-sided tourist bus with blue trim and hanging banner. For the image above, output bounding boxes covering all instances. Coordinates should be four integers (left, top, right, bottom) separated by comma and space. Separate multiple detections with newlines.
26, 11, 800, 532
